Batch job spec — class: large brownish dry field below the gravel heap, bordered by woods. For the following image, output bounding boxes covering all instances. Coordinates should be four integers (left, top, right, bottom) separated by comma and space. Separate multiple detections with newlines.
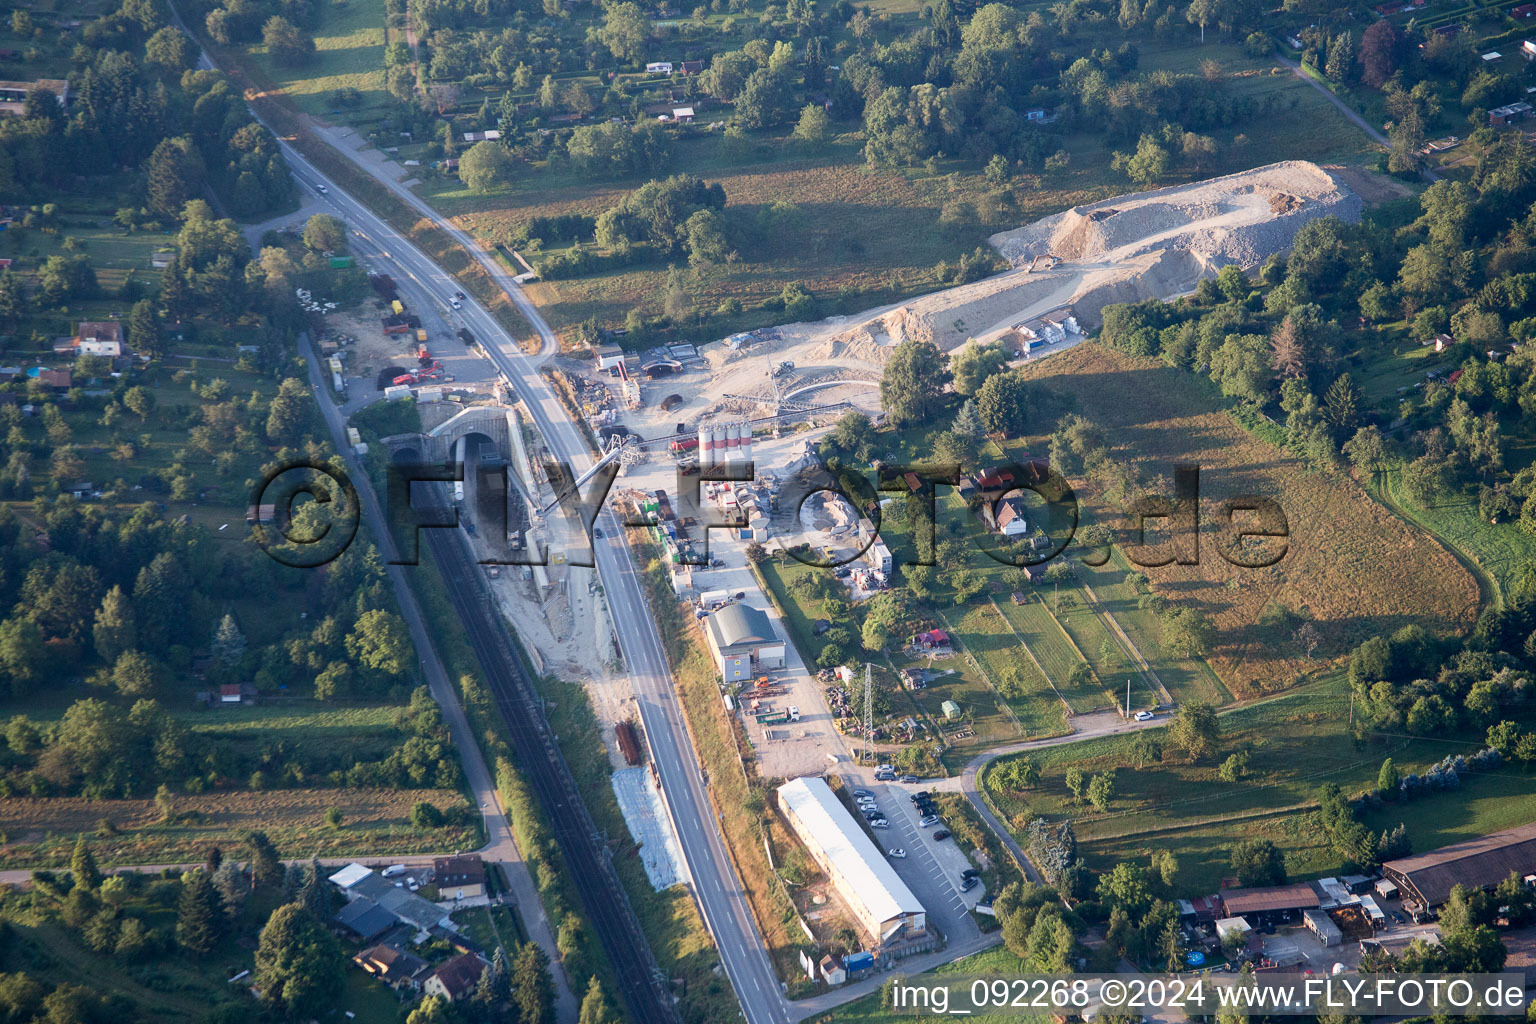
1026, 344, 1478, 697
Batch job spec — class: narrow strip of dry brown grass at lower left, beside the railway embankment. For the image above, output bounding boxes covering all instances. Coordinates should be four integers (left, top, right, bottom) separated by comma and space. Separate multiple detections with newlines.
0, 789, 479, 867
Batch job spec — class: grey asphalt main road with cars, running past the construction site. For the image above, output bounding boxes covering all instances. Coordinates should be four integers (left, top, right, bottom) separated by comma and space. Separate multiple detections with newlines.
270, 143, 800, 1024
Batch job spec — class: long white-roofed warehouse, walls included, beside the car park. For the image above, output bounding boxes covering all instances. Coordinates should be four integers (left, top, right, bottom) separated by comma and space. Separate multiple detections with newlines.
779, 778, 928, 943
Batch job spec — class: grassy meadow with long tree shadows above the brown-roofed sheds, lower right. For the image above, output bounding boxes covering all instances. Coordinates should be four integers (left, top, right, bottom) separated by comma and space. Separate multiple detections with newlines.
985, 674, 1536, 897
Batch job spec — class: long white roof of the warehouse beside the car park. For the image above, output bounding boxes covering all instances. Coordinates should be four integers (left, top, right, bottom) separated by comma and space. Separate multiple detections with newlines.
779, 778, 925, 921
